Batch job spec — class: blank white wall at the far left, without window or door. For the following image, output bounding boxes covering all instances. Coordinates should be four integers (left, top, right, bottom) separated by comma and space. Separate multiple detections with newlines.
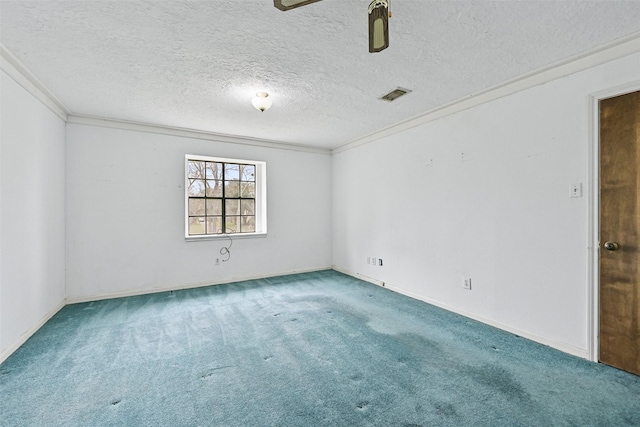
0, 71, 65, 362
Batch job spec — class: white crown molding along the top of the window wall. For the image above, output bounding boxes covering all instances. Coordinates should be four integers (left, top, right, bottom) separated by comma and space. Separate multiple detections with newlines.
67, 114, 331, 155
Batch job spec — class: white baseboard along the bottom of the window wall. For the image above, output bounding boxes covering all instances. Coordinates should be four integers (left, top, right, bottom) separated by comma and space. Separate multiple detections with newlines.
67, 266, 332, 304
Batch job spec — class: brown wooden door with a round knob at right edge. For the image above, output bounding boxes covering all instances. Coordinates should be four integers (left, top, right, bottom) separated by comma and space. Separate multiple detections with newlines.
599, 91, 640, 375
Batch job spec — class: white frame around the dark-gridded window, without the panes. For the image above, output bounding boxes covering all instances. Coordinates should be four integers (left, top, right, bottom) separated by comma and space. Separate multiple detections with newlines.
184, 154, 267, 241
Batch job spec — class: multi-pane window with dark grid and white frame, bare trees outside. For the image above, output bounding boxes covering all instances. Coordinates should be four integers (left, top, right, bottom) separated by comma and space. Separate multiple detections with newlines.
185, 155, 267, 238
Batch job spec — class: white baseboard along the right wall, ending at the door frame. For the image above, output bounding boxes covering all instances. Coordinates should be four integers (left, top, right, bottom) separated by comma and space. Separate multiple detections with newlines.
333, 267, 590, 360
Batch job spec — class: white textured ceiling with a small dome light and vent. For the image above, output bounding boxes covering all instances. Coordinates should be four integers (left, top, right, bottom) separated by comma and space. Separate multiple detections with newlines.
0, 0, 640, 148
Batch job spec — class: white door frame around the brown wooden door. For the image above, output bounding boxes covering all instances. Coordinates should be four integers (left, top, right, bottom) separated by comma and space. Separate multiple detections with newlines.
587, 80, 640, 362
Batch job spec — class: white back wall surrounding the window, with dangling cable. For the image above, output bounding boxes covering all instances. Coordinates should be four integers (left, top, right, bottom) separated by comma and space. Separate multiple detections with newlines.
66, 124, 331, 301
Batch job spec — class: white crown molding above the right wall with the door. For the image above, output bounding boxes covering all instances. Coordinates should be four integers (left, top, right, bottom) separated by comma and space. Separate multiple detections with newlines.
331, 32, 640, 154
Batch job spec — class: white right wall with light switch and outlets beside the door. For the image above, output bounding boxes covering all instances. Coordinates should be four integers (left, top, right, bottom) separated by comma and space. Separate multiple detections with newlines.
333, 54, 640, 357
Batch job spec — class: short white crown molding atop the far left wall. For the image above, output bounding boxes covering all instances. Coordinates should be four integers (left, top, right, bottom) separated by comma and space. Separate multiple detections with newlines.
0, 42, 71, 121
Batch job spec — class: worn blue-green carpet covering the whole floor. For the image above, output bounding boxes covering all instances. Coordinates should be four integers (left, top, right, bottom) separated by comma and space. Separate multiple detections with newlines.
0, 271, 640, 427
